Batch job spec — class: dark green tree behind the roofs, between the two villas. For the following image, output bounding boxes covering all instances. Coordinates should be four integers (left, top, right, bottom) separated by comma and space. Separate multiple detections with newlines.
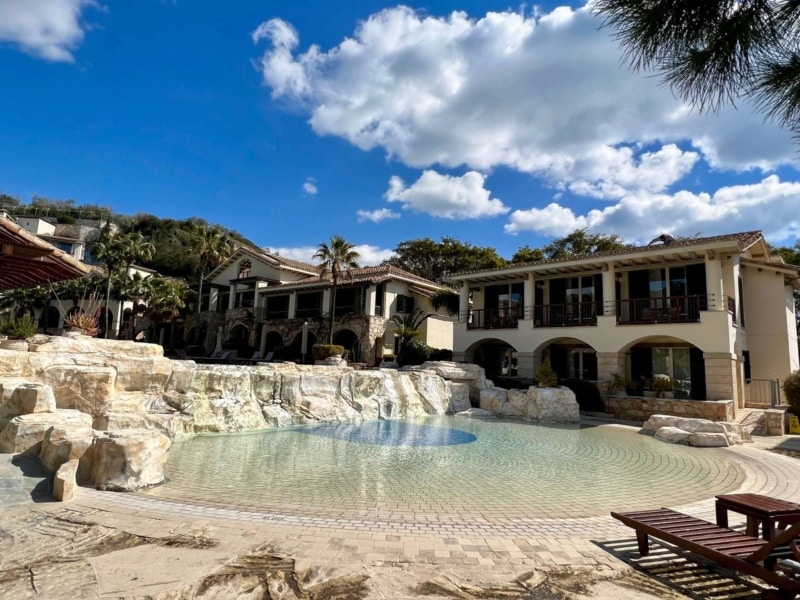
383, 237, 507, 282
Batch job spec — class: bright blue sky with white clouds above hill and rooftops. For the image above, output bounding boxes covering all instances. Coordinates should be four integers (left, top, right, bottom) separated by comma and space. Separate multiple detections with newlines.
0, 0, 800, 264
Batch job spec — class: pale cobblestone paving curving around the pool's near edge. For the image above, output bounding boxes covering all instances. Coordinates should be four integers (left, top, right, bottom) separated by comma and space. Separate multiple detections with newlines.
67, 426, 800, 572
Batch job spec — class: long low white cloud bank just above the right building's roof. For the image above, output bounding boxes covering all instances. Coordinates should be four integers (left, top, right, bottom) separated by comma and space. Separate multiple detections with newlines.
505, 175, 800, 242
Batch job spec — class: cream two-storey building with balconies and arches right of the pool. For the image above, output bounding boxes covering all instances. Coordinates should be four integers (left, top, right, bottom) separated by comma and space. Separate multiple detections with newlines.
449, 231, 800, 407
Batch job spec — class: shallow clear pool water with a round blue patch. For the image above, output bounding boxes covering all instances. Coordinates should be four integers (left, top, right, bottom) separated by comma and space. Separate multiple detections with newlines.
148, 417, 744, 517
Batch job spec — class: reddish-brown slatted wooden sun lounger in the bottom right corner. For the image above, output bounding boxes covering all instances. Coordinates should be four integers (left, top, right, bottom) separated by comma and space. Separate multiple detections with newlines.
611, 508, 800, 598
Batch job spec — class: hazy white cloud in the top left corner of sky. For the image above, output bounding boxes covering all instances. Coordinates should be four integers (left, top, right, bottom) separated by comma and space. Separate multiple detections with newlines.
0, 0, 98, 62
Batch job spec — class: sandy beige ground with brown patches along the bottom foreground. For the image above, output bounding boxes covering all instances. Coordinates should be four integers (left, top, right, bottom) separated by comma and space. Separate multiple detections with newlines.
0, 502, 686, 600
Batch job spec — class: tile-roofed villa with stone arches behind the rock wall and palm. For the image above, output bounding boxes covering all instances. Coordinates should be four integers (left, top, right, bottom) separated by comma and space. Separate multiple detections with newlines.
192, 248, 453, 365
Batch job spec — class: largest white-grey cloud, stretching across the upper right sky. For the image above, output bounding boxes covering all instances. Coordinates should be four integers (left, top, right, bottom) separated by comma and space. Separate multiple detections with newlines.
254, 7, 796, 185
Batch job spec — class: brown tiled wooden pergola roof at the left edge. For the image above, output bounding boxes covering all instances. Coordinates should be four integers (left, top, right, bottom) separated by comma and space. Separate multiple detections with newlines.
0, 215, 89, 292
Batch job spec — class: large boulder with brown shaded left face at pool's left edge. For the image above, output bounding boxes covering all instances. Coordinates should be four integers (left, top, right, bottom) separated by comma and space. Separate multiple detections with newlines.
88, 429, 170, 492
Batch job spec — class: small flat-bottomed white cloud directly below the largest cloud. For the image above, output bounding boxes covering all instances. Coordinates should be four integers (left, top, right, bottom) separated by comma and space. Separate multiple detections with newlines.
385, 170, 509, 219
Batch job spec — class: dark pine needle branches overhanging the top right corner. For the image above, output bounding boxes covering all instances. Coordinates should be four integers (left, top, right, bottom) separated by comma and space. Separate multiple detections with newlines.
593, 0, 800, 136
